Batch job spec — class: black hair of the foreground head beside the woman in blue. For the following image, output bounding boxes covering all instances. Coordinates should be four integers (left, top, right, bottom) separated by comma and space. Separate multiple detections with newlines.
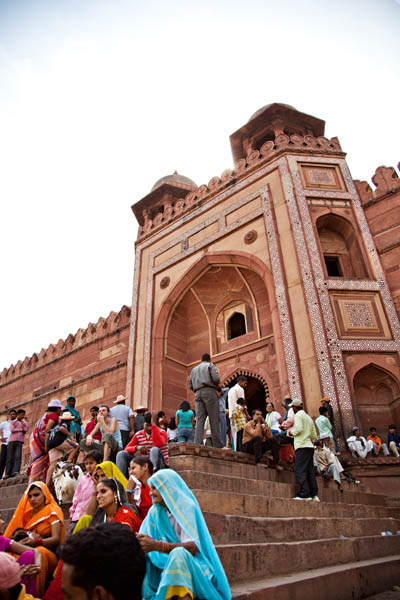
60, 523, 146, 600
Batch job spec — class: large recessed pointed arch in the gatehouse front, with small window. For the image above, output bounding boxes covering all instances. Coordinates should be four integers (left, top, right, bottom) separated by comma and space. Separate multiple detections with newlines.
152, 254, 280, 418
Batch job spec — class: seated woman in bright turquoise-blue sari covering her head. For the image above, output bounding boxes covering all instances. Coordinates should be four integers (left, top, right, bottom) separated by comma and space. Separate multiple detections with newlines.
138, 469, 232, 600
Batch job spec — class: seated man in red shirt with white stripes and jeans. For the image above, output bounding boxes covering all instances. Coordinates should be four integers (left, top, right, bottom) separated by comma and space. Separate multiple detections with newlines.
116, 412, 169, 478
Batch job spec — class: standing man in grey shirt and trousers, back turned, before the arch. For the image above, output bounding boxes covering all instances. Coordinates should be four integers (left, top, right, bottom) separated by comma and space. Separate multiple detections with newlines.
189, 354, 222, 448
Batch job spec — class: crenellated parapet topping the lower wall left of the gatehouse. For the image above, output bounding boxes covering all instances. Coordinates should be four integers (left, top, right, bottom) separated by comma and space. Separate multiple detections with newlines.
0, 305, 131, 387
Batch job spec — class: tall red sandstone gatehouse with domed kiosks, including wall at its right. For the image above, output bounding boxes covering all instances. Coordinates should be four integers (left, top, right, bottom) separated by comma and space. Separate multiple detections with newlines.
127, 104, 400, 436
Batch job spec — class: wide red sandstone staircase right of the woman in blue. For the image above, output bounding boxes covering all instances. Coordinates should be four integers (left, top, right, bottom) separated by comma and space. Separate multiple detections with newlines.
0, 444, 400, 600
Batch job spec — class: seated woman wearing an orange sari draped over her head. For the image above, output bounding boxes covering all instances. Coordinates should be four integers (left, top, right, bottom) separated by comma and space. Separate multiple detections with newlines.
4, 481, 64, 598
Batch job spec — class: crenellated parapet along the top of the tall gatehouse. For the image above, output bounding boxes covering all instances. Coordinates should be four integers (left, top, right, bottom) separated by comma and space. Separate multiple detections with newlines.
132, 133, 345, 241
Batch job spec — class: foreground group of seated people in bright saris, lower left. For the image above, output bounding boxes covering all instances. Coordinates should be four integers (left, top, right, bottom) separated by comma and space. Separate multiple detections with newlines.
0, 446, 231, 600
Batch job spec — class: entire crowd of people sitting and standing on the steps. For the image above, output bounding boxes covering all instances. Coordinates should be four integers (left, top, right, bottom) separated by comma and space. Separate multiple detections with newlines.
0, 354, 400, 600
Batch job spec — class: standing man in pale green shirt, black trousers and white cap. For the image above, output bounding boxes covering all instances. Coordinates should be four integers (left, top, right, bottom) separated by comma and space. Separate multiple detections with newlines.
290, 400, 319, 502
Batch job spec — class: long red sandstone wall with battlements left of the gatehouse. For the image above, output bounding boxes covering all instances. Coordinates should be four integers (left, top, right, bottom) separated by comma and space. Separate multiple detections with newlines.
0, 306, 130, 464
